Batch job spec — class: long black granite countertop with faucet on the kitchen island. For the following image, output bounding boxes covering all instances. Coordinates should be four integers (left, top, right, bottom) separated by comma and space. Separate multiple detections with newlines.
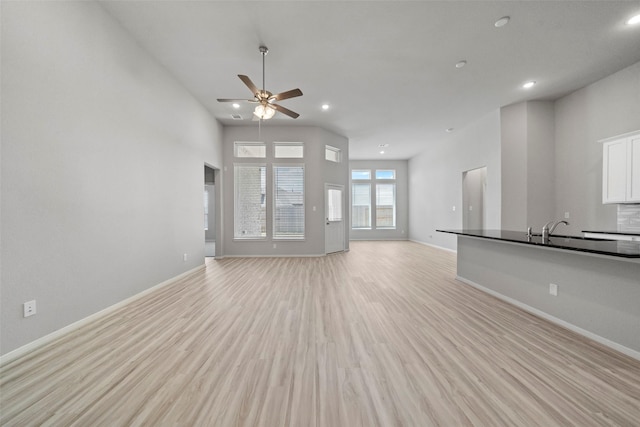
436, 230, 640, 258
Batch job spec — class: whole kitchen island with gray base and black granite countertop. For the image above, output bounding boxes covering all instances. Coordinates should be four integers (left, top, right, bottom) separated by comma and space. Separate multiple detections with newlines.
437, 230, 640, 359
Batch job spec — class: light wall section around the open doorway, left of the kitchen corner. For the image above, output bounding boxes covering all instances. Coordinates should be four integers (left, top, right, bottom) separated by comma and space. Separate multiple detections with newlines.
409, 110, 501, 249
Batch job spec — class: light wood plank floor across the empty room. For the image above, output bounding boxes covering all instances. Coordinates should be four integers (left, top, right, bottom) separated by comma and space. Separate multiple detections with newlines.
0, 242, 640, 427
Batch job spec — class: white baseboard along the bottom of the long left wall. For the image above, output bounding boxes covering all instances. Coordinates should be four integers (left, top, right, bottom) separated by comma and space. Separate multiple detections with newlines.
0, 264, 205, 367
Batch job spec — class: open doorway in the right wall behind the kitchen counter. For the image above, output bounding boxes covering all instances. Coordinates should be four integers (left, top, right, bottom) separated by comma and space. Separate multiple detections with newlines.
462, 166, 487, 230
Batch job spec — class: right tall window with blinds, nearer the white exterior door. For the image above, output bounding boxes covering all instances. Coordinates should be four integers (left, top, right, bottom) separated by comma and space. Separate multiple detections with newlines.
273, 165, 304, 239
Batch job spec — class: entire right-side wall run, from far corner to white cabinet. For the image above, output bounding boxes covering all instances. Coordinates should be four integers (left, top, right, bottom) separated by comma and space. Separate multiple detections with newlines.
409, 62, 640, 249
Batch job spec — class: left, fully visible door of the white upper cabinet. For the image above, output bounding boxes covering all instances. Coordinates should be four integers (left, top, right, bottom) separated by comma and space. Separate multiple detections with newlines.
602, 138, 628, 203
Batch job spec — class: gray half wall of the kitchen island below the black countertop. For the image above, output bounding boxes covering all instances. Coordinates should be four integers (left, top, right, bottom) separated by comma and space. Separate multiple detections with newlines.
458, 237, 640, 357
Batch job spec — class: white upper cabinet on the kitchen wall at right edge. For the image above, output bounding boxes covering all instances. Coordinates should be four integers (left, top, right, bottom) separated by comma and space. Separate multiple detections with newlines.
600, 131, 640, 203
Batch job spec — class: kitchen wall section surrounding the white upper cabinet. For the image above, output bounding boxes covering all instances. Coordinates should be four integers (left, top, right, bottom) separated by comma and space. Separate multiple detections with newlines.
555, 62, 640, 234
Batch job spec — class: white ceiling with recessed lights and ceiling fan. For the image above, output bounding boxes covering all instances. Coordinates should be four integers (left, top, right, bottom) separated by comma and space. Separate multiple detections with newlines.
101, 0, 640, 159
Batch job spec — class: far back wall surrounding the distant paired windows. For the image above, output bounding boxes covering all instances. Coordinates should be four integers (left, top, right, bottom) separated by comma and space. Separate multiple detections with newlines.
347, 160, 409, 240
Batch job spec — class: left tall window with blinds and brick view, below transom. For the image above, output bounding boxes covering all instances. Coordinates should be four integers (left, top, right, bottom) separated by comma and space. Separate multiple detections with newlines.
233, 164, 267, 239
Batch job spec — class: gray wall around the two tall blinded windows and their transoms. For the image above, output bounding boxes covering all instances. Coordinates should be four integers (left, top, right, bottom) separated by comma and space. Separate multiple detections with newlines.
221, 125, 349, 257
